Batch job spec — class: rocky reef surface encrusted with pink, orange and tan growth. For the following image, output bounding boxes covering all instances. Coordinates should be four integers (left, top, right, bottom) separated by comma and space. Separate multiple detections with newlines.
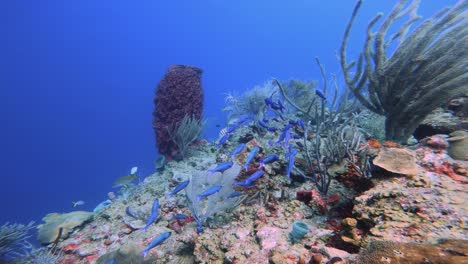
36, 127, 468, 263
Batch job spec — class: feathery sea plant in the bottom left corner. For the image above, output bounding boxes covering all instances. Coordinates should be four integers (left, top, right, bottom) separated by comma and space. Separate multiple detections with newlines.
0, 222, 35, 262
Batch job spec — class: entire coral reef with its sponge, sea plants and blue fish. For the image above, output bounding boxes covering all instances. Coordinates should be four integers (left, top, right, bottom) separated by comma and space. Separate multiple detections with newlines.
7, 0, 468, 264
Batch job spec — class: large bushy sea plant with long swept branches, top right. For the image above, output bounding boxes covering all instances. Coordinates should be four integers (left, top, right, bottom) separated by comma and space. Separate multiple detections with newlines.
340, 0, 468, 143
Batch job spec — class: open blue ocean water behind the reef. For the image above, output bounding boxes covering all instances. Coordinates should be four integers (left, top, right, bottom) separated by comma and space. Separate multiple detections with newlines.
0, 0, 455, 233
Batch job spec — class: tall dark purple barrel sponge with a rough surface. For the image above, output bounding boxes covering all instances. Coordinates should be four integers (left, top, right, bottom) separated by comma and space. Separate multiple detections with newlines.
153, 65, 203, 159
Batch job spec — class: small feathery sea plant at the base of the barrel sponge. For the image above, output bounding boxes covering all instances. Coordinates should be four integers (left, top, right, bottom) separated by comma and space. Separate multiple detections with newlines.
168, 115, 205, 159
